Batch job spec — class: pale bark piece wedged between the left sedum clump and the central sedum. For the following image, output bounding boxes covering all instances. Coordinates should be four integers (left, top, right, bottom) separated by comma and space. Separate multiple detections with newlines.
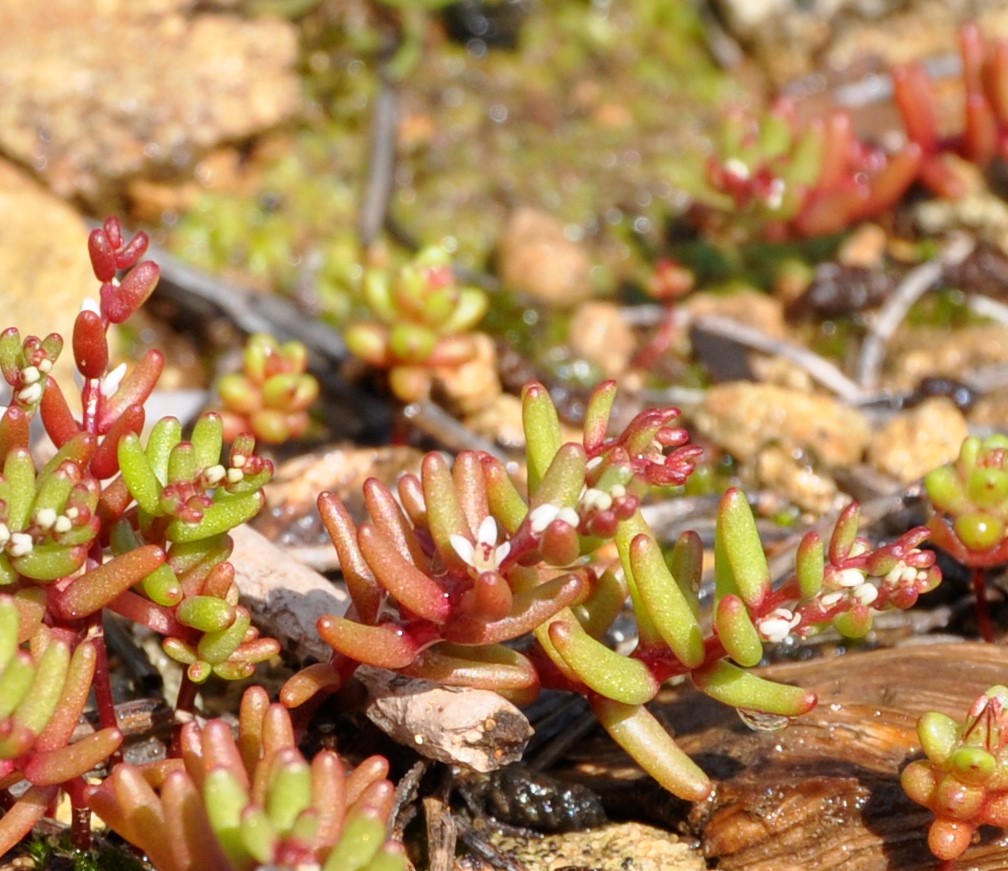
231, 524, 350, 661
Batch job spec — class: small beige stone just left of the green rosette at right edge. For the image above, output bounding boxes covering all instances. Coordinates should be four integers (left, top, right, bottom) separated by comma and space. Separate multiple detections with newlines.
868, 396, 969, 484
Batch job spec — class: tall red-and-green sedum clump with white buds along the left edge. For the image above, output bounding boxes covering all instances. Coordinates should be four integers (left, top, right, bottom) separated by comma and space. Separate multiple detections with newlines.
0, 219, 279, 853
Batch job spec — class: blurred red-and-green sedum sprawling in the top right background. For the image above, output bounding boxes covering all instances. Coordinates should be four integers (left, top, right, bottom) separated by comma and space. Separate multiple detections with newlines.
692, 23, 1008, 242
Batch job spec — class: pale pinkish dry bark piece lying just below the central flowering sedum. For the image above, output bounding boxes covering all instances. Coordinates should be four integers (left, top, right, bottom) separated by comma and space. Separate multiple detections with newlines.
355, 665, 532, 771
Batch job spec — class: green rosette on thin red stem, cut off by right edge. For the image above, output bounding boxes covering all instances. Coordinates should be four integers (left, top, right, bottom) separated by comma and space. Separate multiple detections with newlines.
924, 434, 1008, 641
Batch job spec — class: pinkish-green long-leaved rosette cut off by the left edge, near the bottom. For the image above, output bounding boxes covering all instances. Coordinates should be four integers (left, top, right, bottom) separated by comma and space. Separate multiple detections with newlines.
0, 590, 123, 855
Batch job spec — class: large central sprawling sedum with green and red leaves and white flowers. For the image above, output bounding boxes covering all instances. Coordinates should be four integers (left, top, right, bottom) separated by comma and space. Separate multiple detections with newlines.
281, 382, 940, 799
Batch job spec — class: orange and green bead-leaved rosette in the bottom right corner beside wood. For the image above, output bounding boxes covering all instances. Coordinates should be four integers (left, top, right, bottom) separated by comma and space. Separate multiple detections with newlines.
900, 687, 1008, 861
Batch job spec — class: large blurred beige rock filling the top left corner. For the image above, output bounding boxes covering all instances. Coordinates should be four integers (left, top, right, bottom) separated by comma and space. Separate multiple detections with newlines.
0, 0, 300, 199
